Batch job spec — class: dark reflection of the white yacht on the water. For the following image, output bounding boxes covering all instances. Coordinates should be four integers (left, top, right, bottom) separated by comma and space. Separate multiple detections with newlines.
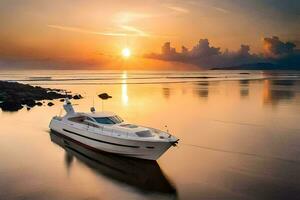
50, 131, 177, 199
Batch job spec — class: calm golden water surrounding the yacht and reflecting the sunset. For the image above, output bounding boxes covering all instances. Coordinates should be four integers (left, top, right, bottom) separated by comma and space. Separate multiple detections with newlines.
0, 71, 300, 200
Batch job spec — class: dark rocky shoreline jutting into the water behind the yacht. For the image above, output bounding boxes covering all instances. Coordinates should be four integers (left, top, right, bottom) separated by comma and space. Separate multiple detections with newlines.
0, 81, 82, 111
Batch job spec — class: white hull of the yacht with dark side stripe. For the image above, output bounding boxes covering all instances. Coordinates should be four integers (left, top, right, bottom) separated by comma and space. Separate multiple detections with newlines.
49, 118, 173, 160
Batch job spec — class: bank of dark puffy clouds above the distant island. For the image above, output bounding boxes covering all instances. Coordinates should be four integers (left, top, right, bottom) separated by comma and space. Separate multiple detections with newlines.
145, 36, 300, 69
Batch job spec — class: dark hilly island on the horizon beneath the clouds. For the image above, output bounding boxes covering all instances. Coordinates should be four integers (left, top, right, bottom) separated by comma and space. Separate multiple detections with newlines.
210, 62, 300, 70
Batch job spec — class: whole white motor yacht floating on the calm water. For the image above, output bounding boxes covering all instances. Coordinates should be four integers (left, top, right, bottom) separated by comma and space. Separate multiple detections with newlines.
49, 99, 179, 160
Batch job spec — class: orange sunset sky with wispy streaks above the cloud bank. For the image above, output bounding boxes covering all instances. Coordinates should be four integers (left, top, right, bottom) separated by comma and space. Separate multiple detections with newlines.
0, 0, 300, 67
